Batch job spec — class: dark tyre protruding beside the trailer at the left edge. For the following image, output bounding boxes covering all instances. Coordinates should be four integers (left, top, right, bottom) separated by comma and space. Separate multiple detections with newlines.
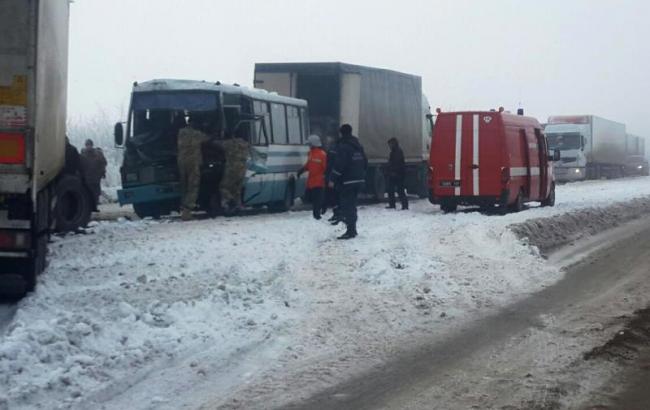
54, 175, 92, 232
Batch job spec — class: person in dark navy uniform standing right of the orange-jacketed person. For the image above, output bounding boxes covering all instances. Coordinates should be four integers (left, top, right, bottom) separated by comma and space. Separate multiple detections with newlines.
329, 124, 368, 239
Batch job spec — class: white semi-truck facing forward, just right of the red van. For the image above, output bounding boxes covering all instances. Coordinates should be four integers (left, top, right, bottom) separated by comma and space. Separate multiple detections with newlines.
544, 115, 627, 182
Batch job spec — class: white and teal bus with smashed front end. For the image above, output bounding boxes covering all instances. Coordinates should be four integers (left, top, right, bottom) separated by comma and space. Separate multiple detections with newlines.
115, 80, 309, 218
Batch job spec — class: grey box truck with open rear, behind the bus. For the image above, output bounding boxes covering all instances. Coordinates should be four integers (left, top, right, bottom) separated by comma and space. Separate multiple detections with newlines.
255, 63, 433, 200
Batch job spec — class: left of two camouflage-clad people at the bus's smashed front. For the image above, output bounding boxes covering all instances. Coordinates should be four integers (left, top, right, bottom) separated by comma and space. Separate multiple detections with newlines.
177, 114, 208, 221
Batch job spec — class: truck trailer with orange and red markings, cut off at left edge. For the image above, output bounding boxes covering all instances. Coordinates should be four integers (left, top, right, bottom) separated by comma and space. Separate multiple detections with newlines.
0, 0, 94, 294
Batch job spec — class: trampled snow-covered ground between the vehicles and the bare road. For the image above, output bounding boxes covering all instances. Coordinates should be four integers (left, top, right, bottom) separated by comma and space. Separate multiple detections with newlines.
0, 177, 650, 409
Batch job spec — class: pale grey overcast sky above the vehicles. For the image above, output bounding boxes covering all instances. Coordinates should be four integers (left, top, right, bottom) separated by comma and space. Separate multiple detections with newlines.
69, 0, 650, 137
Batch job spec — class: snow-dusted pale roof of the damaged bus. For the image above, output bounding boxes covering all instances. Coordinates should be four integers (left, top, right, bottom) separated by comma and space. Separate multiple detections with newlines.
133, 79, 307, 107
